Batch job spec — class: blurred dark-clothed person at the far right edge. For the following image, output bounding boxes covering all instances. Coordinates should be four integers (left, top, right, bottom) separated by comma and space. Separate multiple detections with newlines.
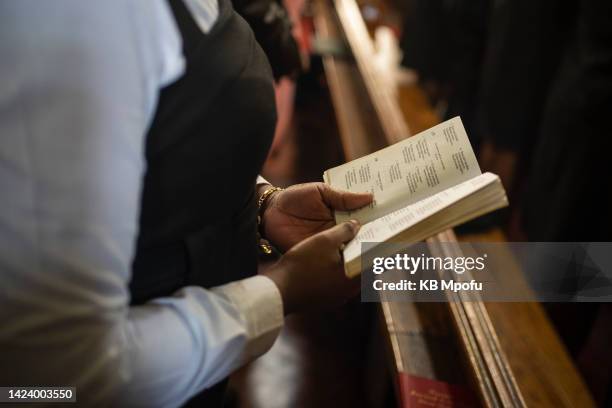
523, 0, 612, 241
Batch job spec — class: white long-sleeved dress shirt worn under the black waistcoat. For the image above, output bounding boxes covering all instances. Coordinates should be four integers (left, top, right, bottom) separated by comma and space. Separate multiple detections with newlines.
0, 0, 283, 407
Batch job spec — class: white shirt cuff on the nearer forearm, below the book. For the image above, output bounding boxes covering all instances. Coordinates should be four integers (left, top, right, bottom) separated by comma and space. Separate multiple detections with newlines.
211, 275, 284, 362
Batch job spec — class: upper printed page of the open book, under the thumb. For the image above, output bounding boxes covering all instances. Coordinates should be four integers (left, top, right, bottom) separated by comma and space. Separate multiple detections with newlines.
323, 117, 480, 225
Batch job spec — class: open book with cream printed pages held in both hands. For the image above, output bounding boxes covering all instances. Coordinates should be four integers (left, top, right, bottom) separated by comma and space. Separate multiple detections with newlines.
323, 117, 508, 276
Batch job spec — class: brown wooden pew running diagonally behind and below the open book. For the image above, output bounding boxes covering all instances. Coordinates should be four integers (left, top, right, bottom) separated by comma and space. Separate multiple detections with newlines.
313, 0, 594, 407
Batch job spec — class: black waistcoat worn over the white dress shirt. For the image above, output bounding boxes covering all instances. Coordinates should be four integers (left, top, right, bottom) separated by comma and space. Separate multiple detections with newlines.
130, 0, 276, 406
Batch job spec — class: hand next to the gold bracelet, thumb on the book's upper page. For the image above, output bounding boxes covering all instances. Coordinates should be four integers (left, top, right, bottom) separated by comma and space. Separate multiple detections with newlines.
263, 183, 373, 252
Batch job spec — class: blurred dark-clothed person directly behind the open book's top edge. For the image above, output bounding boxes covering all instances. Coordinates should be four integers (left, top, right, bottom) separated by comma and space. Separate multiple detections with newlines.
400, 0, 490, 149
